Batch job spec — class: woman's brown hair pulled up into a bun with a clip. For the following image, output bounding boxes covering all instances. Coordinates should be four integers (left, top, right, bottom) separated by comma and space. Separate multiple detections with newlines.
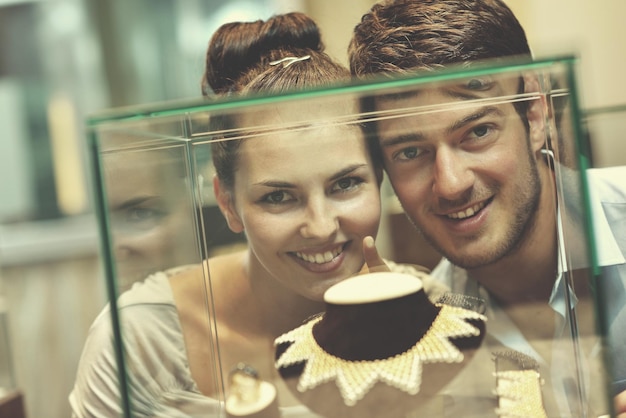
202, 13, 350, 188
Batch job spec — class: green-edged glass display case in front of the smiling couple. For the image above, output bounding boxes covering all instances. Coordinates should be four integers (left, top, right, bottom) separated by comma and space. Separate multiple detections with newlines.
79, 57, 621, 418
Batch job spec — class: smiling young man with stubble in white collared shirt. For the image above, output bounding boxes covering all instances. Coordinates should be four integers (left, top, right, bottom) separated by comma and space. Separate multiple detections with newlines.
349, 0, 626, 416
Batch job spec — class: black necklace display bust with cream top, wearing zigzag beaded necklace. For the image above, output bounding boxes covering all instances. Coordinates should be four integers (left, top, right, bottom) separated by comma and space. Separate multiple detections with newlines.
275, 272, 485, 418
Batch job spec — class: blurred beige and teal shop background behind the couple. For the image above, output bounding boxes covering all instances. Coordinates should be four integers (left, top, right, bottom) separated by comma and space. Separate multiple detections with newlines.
0, 0, 626, 417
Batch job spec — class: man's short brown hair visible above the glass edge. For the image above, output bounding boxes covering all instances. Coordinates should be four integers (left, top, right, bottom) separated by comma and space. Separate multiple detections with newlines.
348, 0, 531, 77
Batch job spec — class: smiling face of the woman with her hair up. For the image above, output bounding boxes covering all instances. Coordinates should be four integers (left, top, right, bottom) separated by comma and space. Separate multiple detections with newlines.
219, 104, 380, 300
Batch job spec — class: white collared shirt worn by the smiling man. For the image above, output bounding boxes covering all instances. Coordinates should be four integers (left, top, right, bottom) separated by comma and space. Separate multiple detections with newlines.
432, 167, 626, 416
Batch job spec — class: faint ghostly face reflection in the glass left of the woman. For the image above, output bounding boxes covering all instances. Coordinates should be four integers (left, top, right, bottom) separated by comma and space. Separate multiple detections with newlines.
104, 151, 194, 286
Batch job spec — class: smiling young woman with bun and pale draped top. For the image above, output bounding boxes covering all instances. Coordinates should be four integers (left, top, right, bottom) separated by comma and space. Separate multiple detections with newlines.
70, 13, 438, 417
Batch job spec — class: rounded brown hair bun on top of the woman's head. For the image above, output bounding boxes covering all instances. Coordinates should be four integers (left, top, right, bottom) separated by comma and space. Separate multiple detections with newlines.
202, 12, 324, 94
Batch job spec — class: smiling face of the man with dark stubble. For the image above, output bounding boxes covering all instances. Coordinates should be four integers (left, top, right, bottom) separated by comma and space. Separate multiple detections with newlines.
377, 78, 544, 268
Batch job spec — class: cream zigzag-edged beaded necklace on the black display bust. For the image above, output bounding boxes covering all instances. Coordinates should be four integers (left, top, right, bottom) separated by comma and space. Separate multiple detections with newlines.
274, 304, 486, 406
